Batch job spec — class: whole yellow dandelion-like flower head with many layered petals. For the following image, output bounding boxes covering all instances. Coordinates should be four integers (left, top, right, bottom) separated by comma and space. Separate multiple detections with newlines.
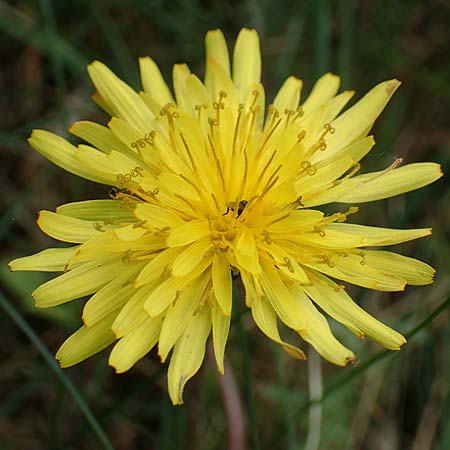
10, 29, 442, 404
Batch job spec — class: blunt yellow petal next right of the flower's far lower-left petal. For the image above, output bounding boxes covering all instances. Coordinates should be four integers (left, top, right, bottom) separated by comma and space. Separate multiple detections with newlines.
109, 317, 161, 373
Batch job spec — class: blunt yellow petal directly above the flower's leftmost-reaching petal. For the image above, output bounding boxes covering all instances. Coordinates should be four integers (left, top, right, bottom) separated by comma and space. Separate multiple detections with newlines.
37, 211, 106, 244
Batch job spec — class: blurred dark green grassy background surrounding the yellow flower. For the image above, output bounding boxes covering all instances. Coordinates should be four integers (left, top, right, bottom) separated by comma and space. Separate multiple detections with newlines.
0, 0, 450, 450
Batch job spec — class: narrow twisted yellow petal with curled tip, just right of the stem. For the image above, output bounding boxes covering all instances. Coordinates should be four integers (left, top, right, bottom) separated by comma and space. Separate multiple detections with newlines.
251, 298, 305, 359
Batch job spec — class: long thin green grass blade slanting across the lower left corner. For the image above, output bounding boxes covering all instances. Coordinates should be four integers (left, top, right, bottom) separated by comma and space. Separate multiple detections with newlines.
0, 292, 114, 450
